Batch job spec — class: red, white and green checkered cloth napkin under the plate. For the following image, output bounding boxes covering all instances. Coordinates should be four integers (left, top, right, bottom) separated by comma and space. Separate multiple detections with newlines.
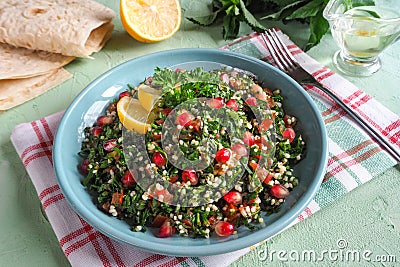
11, 29, 400, 266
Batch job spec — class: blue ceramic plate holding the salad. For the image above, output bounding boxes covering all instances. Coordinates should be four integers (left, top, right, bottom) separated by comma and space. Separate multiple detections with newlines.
53, 49, 327, 256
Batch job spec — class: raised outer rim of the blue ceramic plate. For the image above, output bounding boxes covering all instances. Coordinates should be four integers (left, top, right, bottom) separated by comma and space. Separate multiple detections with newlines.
52, 48, 328, 256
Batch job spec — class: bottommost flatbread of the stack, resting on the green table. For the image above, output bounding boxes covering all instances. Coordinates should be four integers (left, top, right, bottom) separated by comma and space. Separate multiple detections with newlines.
0, 68, 72, 111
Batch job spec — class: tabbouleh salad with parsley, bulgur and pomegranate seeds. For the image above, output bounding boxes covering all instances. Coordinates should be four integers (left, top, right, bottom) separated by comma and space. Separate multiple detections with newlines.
79, 68, 305, 238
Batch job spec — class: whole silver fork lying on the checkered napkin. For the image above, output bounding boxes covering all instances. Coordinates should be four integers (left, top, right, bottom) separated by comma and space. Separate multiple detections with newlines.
261, 29, 400, 163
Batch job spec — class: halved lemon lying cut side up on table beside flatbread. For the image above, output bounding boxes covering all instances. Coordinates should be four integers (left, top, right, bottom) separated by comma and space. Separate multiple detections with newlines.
120, 0, 182, 43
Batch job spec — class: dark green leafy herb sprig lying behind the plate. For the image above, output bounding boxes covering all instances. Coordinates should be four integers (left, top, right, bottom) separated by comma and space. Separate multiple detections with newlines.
186, 0, 329, 50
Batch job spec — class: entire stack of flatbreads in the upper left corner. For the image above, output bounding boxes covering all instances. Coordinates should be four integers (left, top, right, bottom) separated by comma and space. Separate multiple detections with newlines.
0, 0, 115, 111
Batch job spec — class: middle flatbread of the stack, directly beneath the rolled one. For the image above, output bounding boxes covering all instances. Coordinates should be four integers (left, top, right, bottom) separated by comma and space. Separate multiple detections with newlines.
0, 43, 75, 80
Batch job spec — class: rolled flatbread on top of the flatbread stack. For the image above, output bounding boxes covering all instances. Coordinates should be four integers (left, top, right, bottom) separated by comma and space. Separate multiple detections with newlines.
0, 0, 115, 58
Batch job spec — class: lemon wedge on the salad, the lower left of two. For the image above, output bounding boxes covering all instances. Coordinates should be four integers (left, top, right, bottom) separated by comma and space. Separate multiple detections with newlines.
117, 96, 151, 134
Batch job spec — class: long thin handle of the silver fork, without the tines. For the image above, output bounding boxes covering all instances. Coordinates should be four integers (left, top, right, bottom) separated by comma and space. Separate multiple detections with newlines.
301, 81, 400, 163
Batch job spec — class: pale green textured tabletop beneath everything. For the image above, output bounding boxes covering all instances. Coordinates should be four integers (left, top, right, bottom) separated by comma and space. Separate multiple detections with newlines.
0, 0, 400, 266
